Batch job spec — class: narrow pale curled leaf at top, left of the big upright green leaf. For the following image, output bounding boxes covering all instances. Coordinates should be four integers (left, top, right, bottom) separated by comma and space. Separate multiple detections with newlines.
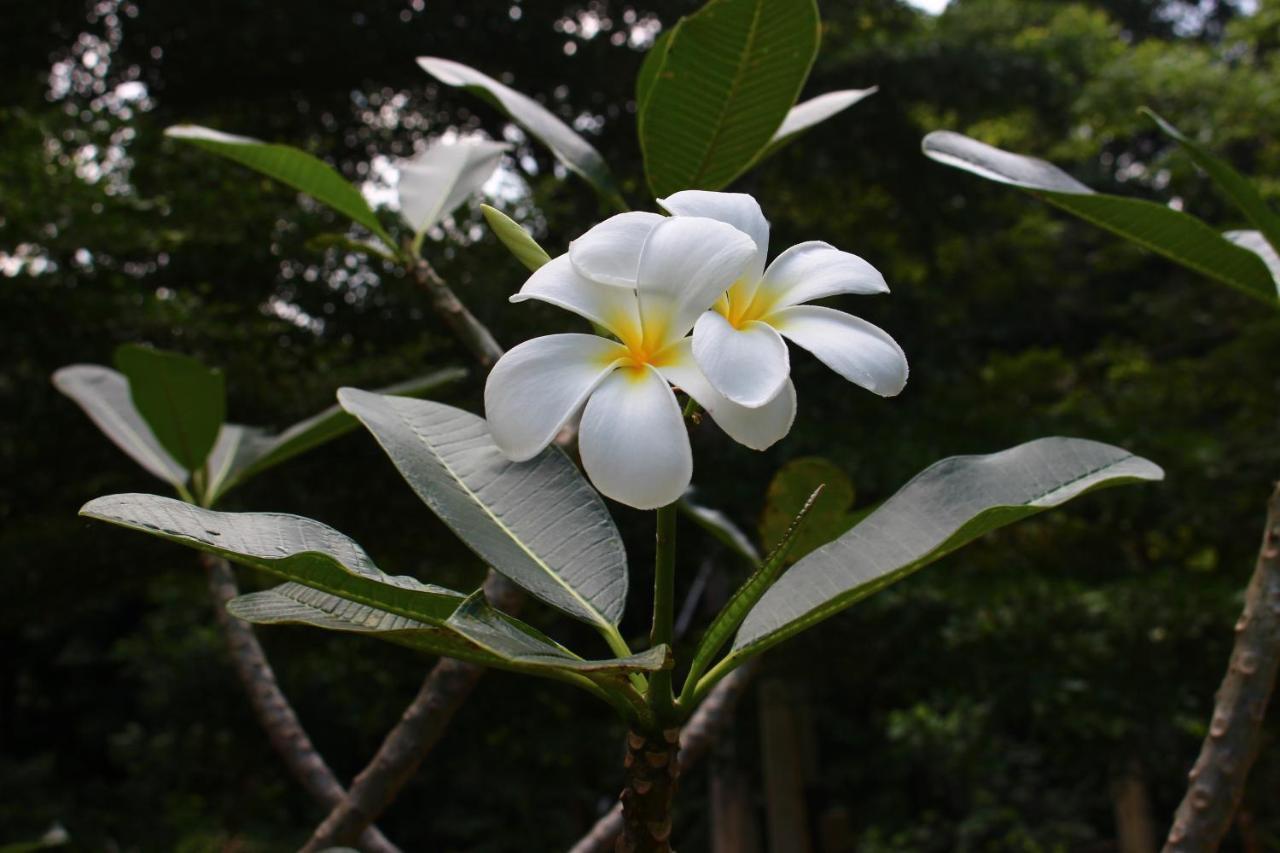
417, 56, 626, 209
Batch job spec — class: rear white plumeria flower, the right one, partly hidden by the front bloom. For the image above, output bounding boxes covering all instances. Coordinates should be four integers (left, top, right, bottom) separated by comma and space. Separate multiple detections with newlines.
570, 190, 908, 407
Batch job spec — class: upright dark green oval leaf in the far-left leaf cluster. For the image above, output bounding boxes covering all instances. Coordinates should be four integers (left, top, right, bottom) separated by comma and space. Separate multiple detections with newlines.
115, 343, 227, 471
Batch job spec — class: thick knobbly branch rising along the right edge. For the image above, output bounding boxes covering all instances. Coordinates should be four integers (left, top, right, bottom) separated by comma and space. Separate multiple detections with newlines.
1165, 484, 1280, 853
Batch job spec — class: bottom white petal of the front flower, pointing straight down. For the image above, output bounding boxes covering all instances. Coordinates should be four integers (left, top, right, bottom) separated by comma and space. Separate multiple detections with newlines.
577, 366, 694, 510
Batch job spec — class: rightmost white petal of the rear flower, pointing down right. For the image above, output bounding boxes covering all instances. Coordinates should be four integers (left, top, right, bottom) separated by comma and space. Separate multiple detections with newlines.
764, 305, 906, 397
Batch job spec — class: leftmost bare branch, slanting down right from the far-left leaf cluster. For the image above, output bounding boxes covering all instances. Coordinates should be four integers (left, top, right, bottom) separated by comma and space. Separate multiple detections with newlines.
200, 553, 399, 853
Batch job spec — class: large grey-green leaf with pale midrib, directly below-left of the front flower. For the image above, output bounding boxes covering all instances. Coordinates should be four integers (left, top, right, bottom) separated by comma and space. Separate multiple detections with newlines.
338, 388, 627, 631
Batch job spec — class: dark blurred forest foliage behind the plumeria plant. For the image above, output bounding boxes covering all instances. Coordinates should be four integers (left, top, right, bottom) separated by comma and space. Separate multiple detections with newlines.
0, 0, 1280, 852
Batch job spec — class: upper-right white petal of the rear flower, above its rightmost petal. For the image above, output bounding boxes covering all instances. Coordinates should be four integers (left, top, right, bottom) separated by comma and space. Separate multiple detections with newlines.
760, 240, 888, 309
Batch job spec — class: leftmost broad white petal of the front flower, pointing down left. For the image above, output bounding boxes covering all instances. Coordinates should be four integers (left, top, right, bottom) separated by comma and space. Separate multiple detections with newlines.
484, 334, 626, 462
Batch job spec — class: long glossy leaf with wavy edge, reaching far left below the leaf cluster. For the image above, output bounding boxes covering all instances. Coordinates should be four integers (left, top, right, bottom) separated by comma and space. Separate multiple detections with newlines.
81, 494, 463, 625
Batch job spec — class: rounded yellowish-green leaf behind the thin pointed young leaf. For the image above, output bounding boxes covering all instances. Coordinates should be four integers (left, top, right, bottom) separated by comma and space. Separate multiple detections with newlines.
760, 456, 858, 562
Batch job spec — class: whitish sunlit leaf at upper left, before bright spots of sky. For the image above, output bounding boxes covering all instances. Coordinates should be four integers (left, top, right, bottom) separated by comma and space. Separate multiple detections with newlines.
396, 137, 511, 236
